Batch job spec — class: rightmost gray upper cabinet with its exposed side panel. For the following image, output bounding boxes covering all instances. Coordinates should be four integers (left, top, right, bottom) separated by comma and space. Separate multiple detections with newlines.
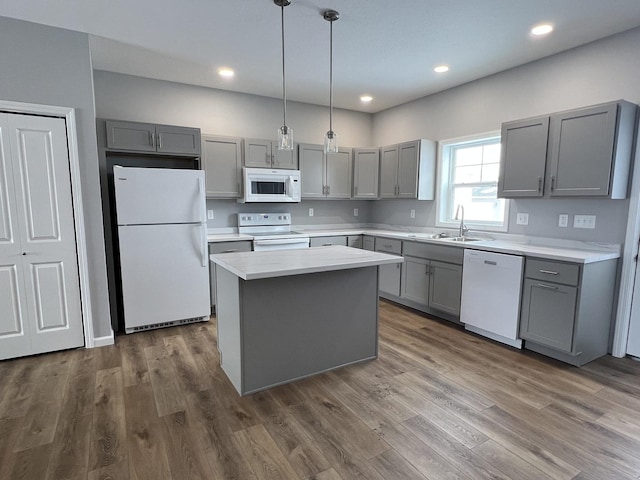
549, 102, 636, 198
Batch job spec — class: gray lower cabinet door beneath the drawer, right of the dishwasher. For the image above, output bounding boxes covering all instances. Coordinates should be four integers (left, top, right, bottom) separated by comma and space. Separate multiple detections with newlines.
520, 278, 578, 352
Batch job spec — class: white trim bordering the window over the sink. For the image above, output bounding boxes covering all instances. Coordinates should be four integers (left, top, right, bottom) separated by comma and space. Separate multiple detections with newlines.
436, 130, 510, 232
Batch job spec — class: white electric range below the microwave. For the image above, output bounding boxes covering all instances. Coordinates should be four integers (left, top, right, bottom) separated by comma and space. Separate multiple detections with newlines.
238, 213, 309, 252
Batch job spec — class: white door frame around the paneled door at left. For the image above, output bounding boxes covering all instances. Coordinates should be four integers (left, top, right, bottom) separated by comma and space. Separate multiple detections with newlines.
0, 100, 97, 348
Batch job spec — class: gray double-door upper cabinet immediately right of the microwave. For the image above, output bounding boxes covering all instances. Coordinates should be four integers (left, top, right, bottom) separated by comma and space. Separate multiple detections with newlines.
298, 144, 352, 199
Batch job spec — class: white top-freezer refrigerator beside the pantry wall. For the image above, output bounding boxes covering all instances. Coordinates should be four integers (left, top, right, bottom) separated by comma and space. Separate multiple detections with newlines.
113, 166, 211, 333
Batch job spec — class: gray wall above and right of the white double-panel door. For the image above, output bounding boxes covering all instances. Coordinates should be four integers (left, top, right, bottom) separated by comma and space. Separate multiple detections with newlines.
0, 17, 111, 337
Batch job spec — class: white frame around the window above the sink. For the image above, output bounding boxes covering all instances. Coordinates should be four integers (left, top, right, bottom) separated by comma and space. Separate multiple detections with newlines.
436, 130, 510, 232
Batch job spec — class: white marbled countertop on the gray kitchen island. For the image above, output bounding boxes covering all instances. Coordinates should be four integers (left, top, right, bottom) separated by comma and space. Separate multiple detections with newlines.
210, 246, 404, 280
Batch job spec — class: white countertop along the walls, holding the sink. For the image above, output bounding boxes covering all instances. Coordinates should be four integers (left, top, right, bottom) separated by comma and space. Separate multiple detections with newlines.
207, 228, 620, 263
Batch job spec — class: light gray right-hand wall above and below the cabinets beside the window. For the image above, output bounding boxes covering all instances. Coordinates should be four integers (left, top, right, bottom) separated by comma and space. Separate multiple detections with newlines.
372, 28, 640, 243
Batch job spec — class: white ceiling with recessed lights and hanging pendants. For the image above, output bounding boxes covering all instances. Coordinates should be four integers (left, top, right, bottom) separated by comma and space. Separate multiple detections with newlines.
0, 0, 640, 112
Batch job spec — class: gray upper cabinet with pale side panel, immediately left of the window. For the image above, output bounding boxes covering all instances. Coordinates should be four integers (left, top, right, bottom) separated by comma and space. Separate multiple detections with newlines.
380, 140, 436, 200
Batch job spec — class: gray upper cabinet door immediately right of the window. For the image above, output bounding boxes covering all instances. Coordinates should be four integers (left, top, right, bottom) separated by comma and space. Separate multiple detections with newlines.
498, 117, 549, 198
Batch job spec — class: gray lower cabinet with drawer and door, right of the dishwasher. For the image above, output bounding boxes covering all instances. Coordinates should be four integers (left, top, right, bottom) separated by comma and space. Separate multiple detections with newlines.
520, 258, 617, 366
